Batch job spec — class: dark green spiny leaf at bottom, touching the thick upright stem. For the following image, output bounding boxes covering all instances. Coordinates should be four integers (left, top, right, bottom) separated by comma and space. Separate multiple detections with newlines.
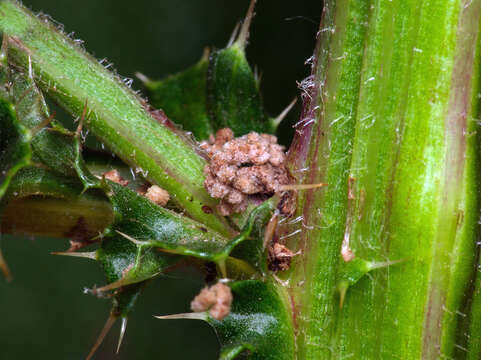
158, 280, 295, 360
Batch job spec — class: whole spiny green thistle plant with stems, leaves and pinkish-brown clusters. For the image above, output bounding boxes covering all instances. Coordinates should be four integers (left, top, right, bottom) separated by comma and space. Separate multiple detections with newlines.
0, 0, 481, 360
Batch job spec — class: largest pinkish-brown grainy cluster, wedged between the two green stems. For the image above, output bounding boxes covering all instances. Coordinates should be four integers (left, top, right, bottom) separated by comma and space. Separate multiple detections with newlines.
201, 128, 290, 216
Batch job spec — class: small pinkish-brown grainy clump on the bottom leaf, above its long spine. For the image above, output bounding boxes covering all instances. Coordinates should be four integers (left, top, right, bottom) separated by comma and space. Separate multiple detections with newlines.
190, 283, 232, 320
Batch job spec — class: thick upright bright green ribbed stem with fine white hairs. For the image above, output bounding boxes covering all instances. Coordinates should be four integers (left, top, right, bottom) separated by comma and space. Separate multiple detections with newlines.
284, 0, 481, 359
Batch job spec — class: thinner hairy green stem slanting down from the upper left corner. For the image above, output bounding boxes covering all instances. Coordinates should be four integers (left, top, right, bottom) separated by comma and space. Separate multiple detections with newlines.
0, 0, 233, 236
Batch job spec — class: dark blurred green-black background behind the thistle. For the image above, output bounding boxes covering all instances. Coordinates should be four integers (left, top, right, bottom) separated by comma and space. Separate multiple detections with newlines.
0, 0, 322, 360
